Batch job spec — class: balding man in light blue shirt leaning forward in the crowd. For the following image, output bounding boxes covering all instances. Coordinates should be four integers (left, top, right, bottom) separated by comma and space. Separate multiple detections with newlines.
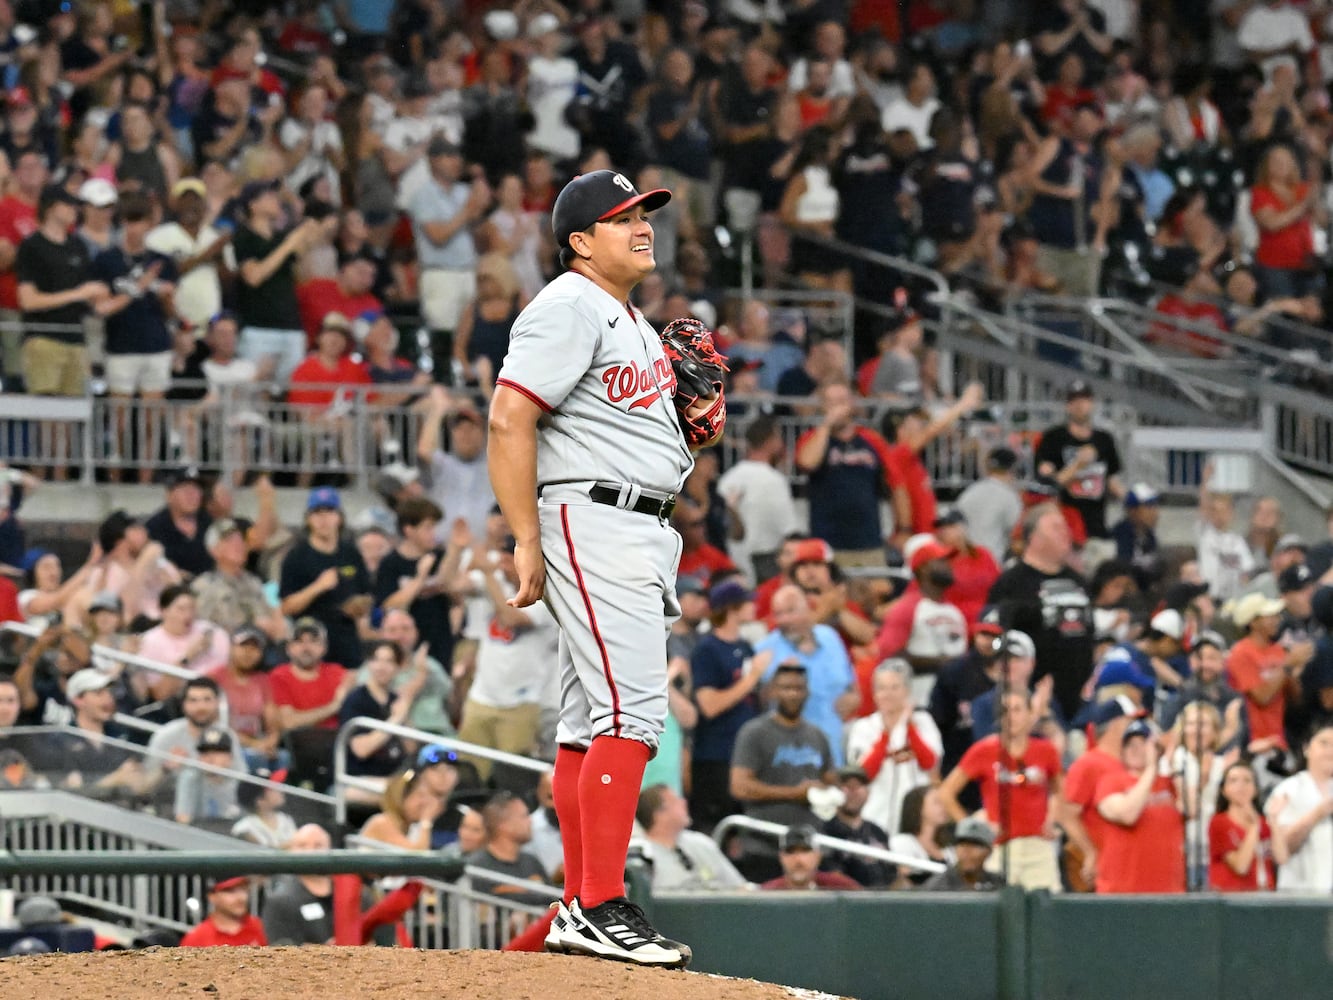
754, 587, 861, 767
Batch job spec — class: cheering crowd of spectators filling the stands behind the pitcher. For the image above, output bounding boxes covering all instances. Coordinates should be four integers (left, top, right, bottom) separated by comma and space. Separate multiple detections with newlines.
0, 0, 1333, 943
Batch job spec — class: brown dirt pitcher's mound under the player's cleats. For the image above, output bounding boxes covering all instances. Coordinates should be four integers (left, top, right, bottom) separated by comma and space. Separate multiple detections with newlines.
0, 947, 853, 1000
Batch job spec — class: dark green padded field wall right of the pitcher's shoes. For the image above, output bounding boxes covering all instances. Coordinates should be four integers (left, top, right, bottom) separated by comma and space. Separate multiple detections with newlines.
651, 889, 1333, 1000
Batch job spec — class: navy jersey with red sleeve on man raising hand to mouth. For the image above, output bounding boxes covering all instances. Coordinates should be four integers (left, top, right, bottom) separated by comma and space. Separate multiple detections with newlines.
797, 428, 889, 549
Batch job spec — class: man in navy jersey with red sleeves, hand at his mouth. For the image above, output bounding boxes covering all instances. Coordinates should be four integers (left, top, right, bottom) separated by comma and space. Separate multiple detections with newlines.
796, 385, 896, 565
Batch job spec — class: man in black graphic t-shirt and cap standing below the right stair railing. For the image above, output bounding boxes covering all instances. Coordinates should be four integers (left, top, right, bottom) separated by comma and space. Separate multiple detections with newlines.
1033, 379, 1125, 556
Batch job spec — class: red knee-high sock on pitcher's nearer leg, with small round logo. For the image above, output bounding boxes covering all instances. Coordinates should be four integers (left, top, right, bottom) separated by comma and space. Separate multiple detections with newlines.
578, 736, 649, 909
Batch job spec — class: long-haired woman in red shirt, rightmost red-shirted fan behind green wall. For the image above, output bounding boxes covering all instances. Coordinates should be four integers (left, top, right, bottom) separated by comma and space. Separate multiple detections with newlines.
1208, 761, 1277, 892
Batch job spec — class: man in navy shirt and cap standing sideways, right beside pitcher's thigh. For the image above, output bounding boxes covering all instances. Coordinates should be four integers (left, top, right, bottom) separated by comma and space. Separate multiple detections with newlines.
682, 584, 772, 832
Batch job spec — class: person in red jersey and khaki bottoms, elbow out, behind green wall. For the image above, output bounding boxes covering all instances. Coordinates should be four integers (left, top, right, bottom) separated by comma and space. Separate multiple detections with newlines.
940, 691, 1061, 892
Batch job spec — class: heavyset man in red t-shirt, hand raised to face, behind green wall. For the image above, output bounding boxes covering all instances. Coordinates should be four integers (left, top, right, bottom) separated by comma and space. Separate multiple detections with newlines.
1094, 719, 1185, 893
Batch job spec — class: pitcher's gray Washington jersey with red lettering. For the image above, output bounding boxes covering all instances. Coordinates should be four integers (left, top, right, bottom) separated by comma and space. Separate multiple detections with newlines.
496, 271, 694, 492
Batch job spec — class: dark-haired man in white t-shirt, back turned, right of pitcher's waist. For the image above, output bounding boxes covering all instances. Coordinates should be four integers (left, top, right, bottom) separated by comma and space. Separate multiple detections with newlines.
717, 416, 798, 583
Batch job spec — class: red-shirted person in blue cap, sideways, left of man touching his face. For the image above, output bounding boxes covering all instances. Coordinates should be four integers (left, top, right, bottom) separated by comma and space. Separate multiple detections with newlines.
1060, 695, 1144, 892
